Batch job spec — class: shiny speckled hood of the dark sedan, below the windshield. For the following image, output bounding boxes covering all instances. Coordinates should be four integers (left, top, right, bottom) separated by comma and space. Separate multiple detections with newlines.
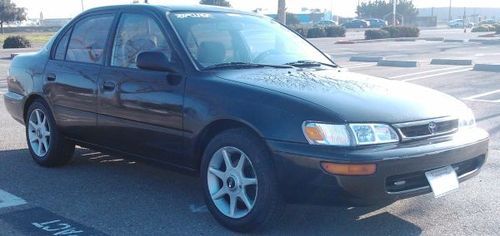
217, 69, 467, 123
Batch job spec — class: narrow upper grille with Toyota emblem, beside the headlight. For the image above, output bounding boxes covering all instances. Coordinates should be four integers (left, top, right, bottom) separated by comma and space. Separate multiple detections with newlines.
394, 118, 458, 141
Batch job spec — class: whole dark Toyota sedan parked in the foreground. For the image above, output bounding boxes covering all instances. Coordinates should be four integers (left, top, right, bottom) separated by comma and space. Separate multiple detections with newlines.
4, 4, 489, 232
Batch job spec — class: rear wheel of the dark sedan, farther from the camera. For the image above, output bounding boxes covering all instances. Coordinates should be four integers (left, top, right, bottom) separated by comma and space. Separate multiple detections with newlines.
25, 100, 75, 167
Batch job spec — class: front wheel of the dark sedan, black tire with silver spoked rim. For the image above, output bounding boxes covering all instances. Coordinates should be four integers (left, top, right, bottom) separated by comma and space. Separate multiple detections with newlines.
201, 129, 285, 232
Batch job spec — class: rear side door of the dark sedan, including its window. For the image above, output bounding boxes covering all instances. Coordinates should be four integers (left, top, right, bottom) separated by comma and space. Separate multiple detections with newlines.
43, 13, 115, 141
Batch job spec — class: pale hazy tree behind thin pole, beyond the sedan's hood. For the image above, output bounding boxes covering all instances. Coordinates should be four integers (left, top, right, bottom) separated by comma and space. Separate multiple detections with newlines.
356, 0, 418, 23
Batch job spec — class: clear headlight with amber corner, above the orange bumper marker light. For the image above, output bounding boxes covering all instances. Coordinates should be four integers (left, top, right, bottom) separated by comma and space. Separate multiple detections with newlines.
303, 122, 399, 146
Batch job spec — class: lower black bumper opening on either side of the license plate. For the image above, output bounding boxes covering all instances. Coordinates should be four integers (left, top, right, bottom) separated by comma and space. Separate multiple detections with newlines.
385, 155, 484, 193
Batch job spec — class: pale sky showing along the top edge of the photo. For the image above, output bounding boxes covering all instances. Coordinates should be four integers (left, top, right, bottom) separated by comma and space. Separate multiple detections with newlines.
13, 0, 500, 18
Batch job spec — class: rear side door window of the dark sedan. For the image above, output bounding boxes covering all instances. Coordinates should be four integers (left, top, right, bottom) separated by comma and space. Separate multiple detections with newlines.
66, 14, 114, 64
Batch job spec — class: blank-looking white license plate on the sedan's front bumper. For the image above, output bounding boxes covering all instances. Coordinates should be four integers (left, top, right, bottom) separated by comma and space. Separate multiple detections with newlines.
425, 166, 458, 198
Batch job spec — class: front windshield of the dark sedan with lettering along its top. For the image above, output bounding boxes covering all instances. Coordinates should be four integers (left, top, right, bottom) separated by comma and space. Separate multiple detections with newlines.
168, 12, 333, 69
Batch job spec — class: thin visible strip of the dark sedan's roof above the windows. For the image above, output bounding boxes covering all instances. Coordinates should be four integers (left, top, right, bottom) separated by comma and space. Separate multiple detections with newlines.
86, 3, 257, 15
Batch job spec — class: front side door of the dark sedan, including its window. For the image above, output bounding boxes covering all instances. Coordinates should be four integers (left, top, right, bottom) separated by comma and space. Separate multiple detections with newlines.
98, 12, 184, 164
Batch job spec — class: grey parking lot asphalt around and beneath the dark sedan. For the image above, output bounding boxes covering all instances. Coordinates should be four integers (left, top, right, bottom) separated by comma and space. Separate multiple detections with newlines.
0, 30, 500, 235
